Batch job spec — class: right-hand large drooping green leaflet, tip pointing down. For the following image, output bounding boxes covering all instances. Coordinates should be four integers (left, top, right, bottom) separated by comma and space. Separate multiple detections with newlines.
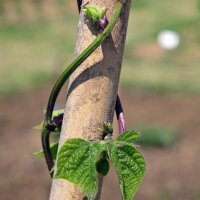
109, 141, 146, 200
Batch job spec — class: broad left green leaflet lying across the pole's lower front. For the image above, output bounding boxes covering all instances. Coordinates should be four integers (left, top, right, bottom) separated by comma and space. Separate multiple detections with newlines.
55, 139, 105, 200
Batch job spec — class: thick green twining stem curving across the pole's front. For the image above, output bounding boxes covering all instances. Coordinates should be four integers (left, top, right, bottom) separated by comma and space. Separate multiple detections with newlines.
41, 0, 125, 176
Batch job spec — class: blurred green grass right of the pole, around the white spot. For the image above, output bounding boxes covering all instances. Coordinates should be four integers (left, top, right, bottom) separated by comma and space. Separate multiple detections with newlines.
121, 0, 200, 94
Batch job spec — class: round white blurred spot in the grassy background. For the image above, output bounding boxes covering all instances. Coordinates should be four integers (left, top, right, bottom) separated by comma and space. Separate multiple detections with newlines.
157, 30, 180, 49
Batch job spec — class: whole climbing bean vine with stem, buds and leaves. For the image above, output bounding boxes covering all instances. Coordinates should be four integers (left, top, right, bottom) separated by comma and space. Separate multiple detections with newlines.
35, 0, 146, 200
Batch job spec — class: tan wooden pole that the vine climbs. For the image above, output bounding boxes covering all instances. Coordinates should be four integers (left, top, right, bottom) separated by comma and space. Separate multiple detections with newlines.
50, 0, 131, 200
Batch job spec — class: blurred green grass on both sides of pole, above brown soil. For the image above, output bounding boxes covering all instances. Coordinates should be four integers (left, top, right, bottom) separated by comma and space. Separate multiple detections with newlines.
0, 0, 200, 97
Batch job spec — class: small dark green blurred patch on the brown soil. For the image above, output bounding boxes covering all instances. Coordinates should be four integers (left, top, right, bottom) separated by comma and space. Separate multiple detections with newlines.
136, 125, 178, 148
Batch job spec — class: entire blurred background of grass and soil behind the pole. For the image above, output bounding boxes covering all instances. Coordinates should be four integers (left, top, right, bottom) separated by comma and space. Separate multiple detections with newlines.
0, 0, 200, 200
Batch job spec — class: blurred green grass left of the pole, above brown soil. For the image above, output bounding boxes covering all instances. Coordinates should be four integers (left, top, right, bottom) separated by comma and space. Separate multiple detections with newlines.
0, 13, 77, 97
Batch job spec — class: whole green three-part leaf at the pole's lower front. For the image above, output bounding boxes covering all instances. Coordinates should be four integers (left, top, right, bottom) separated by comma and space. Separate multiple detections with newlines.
55, 131, 146, 200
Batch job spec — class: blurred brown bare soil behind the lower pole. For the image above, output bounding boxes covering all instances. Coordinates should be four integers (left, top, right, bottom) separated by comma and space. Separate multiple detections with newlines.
0, 87, 200, 200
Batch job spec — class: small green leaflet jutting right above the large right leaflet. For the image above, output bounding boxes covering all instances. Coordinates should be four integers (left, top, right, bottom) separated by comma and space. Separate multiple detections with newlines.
116, 130, 141, 143
